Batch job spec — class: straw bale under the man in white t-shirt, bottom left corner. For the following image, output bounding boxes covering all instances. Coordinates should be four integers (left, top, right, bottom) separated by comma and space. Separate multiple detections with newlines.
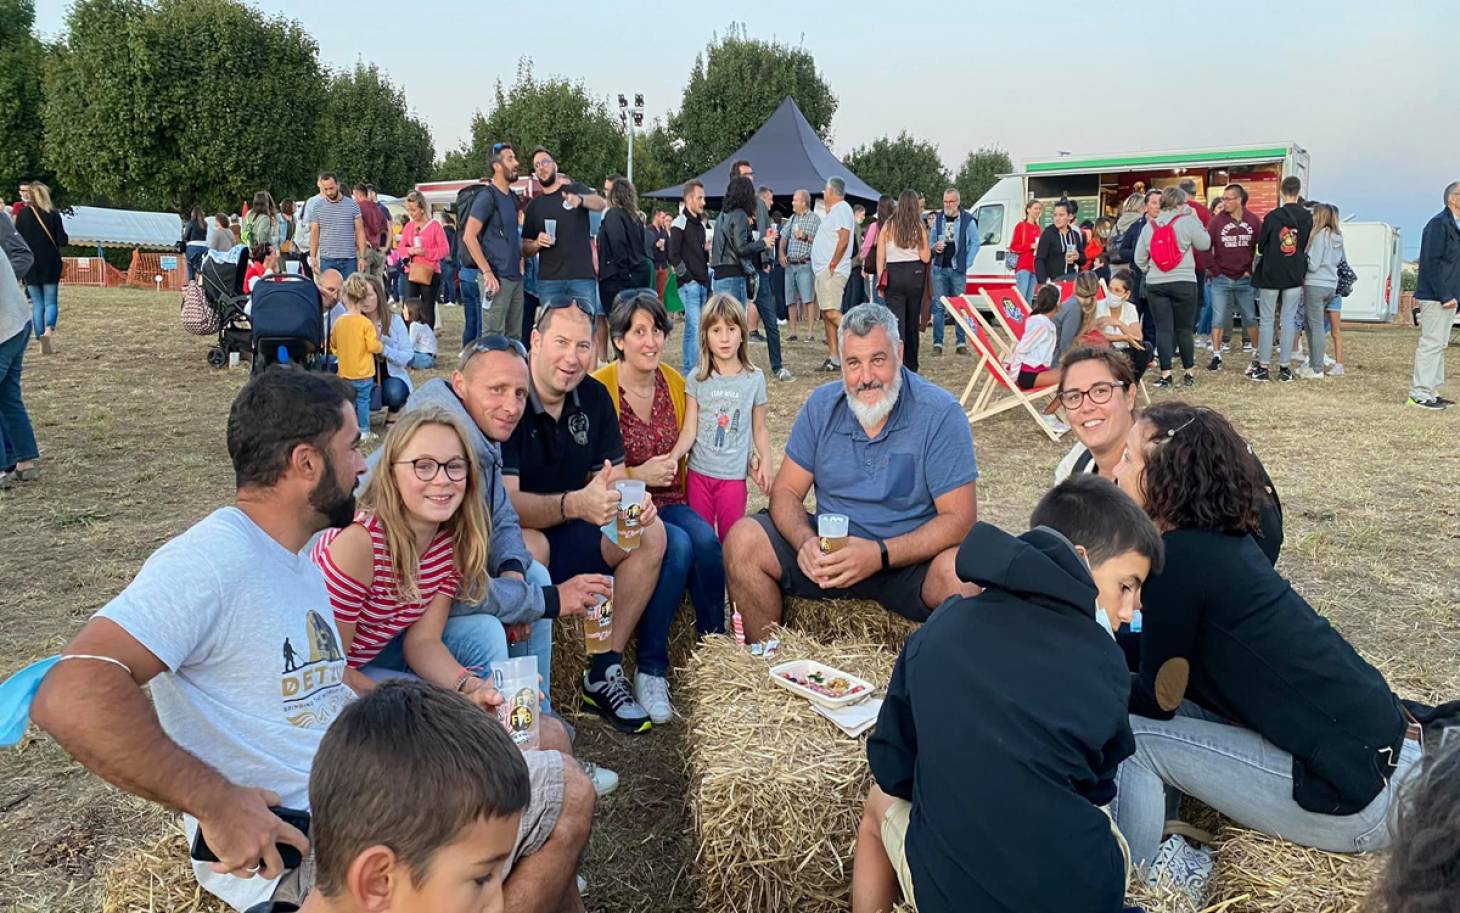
101, 818, 231, 913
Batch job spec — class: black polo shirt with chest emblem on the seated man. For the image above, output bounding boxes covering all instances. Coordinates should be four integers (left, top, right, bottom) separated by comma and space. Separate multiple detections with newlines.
502, 377, 623, 495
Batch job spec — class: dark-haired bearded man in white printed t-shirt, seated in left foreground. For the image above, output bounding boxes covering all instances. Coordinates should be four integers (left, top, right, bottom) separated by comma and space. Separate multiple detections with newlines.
31, 367, 365, 910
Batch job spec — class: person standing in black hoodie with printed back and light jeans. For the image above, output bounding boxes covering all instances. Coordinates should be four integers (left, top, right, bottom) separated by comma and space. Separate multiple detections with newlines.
1247, 175, 1313, 381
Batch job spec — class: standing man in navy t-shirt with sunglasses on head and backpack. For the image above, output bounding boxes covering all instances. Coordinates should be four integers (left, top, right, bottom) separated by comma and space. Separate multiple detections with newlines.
461, 143, 524, 342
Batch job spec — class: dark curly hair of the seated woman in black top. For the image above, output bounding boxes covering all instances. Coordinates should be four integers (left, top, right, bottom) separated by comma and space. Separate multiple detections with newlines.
1137, 402, 1263, 533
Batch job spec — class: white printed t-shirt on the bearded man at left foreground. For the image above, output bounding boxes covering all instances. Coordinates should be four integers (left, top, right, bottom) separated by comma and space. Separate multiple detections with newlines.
96, 507, 355, 910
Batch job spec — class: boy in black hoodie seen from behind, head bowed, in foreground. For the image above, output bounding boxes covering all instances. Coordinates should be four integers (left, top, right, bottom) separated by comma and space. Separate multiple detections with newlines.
851, 475, 1164, 913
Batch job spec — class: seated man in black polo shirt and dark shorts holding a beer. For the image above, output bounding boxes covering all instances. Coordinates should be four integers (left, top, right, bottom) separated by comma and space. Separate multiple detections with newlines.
502, 298, 669, 732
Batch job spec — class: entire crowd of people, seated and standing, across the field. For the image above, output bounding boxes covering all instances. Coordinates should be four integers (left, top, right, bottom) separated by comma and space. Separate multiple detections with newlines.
0, 143, 1460, 913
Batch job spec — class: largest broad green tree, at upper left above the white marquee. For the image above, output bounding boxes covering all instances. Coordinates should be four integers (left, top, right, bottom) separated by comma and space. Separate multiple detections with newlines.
42, 0, 326, 212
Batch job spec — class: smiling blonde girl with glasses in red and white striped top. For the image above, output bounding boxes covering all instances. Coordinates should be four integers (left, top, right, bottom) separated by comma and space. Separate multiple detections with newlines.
311, 408, 501, 708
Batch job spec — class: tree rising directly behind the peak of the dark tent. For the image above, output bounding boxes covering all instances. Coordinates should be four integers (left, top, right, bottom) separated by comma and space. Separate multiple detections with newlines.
669, 25, 837, 180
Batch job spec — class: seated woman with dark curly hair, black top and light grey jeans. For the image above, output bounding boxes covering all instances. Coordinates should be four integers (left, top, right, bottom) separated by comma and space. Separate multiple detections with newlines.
1114, 403, 1421, 888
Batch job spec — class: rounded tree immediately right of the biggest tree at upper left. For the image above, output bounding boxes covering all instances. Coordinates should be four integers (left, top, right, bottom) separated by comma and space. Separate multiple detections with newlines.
317, 61, 435, 196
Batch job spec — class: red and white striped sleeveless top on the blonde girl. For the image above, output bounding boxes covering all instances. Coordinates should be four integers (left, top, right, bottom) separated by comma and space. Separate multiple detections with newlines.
310, 511, 461, 669
